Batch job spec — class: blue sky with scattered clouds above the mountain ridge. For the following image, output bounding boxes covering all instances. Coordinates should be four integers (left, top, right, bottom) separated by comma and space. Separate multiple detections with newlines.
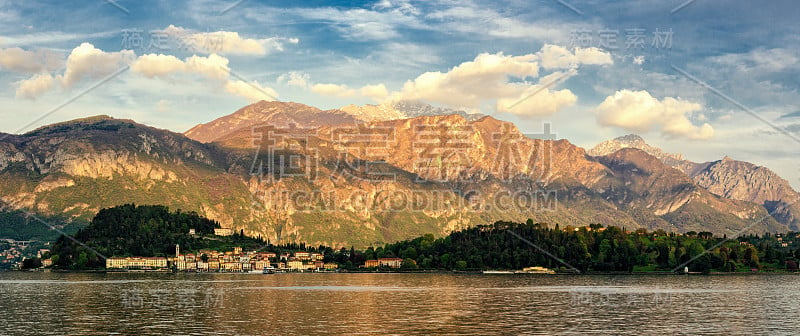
0, 0, 800, 188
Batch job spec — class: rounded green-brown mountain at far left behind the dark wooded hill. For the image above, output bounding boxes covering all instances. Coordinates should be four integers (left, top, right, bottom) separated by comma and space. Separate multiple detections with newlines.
0, 116, 249, 225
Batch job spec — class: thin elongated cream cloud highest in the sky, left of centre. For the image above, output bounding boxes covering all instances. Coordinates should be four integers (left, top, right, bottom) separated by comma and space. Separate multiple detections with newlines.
163, 25, 299, 55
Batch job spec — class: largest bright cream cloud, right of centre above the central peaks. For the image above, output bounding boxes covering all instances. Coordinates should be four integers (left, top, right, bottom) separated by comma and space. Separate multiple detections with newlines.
390, 45, 613, 116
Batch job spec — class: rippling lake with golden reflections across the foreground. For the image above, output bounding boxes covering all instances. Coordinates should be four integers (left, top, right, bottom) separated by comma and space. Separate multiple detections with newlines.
0, 272, 800, 335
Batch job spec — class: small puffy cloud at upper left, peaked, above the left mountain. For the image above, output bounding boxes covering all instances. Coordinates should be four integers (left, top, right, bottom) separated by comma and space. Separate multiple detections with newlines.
61, 42, 136, 87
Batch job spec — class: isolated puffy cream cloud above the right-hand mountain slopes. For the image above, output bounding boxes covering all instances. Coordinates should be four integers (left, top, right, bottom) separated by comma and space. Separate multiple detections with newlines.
596, 90, 714, 140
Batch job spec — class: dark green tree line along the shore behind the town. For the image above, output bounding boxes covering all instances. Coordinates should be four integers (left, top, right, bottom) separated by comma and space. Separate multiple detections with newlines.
23, 204, 800, 274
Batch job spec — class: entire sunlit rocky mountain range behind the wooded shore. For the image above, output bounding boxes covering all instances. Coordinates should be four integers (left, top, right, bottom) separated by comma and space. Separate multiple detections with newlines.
0, 101, 798, 246
